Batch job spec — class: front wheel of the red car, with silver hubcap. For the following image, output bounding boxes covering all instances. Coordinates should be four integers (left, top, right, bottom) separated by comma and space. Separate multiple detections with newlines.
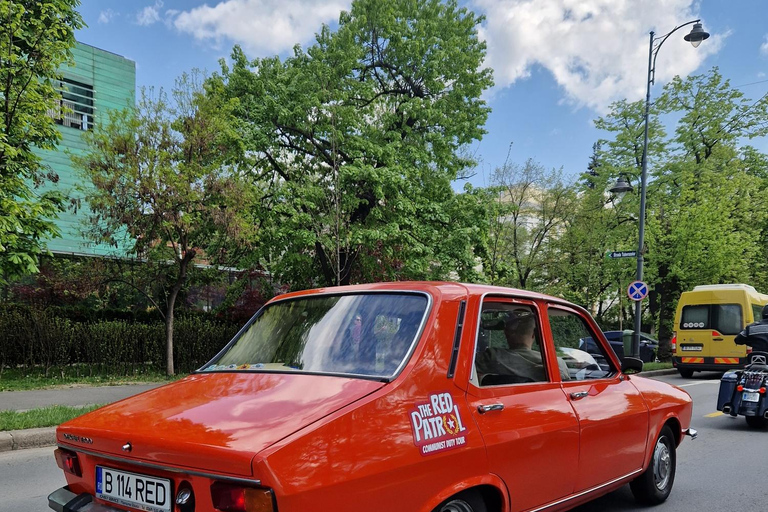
629, 425, 677, 505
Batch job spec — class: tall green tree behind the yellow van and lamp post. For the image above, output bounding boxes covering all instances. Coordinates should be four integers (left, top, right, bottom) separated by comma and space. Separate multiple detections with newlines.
596, 68, 768, 356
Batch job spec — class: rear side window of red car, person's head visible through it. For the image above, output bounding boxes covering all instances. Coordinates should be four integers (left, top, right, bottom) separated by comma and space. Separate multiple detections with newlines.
474, 301, 548, 386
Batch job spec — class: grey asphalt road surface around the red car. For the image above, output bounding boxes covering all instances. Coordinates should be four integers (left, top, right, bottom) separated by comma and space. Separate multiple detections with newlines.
0, 373, 768, 512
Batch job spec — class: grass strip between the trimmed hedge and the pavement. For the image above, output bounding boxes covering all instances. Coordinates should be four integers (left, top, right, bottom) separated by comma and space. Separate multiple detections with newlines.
0, 365, 184, 391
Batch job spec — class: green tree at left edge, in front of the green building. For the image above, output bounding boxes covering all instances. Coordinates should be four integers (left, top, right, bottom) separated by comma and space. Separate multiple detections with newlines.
0, 0, 83, 276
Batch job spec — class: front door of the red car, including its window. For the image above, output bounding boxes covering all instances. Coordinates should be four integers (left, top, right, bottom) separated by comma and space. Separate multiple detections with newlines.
547, 304, 649, 492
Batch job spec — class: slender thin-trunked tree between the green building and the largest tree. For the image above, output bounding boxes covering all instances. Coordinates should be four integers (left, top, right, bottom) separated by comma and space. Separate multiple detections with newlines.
75, 73, 254, 375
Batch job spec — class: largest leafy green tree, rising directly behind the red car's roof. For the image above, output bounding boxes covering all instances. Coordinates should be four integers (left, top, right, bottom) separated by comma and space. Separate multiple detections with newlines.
212, 0, 492, 287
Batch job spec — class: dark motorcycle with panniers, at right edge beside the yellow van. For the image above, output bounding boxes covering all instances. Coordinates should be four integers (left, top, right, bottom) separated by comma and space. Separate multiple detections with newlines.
717, 352, 768, 429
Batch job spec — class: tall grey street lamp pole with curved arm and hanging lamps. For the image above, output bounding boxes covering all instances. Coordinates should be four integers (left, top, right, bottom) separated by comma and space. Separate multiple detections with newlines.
610, 19, 709, 357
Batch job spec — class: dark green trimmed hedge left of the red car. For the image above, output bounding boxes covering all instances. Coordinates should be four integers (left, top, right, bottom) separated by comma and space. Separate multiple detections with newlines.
0, 306, 239, 375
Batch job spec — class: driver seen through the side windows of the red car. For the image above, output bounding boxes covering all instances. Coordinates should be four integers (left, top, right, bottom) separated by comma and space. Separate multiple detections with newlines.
475, 312, 570, 385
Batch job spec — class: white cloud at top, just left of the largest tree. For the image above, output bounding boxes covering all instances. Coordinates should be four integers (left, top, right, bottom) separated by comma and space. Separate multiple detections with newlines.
173, 0, 352, 57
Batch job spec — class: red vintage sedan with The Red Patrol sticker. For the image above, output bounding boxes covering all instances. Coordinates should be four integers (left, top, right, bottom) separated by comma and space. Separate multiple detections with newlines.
49, 282, 696, 512
